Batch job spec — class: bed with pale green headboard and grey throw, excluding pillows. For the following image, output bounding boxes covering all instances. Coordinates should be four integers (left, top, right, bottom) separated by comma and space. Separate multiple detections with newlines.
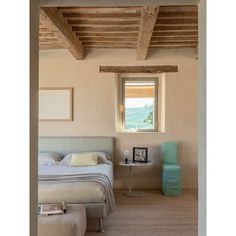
38, 137, 115, 230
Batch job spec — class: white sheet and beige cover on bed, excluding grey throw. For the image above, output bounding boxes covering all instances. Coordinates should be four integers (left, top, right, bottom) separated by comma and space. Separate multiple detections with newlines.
38, 164, 113, 203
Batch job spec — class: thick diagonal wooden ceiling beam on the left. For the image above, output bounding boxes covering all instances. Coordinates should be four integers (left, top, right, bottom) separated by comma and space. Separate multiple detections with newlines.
41, 7, 84, 60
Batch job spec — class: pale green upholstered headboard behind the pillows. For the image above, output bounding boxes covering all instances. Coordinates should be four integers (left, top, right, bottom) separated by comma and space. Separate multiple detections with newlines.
38, 137, 115, 161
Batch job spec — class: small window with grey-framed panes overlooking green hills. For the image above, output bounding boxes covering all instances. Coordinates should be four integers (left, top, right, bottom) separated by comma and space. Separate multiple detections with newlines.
121, 78, 158, 132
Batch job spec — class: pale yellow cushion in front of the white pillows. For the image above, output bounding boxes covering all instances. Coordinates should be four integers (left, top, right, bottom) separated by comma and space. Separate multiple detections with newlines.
69, 153, 97, 166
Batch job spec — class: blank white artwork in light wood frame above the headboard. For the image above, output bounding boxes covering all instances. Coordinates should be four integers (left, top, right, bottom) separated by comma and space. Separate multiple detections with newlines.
39, 88, 73, 121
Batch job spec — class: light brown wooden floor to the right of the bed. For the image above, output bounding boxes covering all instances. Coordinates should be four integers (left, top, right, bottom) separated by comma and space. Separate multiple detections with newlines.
85, 190, 198, 236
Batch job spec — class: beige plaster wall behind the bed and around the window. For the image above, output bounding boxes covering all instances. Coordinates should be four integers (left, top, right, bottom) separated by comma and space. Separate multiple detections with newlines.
39, 49, 198, 188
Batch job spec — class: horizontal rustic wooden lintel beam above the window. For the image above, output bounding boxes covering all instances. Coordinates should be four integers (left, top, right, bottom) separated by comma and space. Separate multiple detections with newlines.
99, 65, 178, 73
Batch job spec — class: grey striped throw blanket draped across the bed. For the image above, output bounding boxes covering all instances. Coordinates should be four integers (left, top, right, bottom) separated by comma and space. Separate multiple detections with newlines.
38, 173, 115, 213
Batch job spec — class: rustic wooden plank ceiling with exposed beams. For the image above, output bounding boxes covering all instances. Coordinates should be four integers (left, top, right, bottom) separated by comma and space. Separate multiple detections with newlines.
39, 5, 198, 60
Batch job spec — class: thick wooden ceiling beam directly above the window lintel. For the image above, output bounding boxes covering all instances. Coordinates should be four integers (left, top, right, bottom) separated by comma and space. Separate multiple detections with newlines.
137, 6, 160, 60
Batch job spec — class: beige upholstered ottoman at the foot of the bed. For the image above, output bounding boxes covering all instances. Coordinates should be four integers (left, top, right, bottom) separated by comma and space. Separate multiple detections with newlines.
38, 205, 87, 236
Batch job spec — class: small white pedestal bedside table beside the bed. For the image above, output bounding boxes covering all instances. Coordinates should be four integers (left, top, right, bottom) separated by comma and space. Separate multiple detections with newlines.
119, 161, 153, 197
